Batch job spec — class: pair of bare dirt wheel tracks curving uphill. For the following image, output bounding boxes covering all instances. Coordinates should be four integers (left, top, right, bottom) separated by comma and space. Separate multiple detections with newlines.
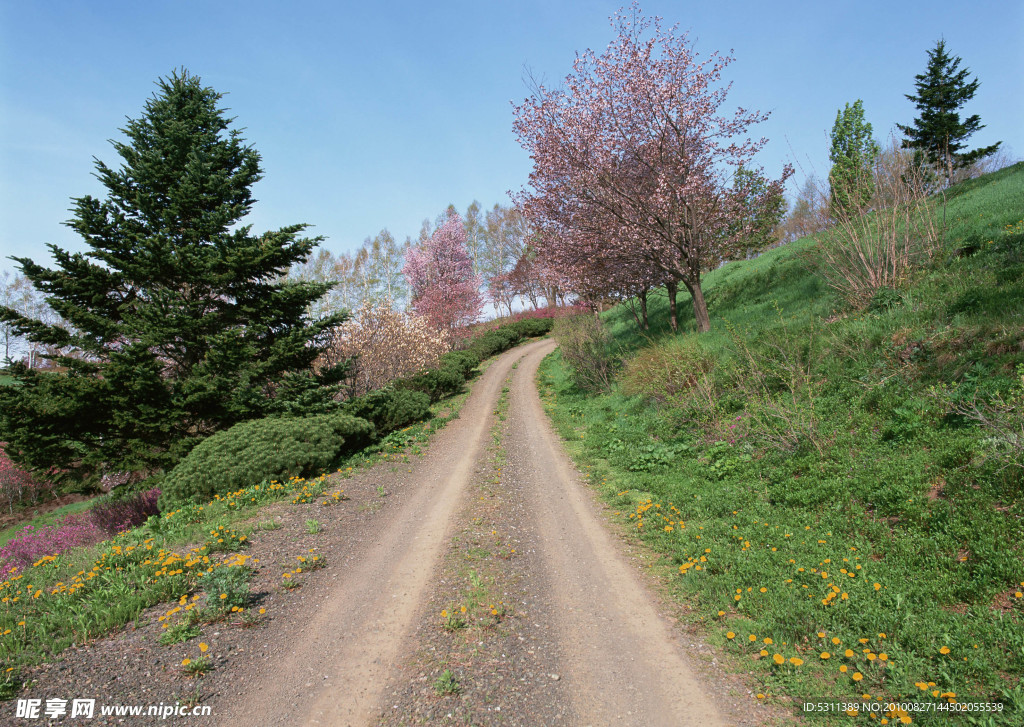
214, 341, 734, 727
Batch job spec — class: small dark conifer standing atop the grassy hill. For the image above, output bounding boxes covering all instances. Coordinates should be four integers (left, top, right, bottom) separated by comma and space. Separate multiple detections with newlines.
896, 40, 1001, 184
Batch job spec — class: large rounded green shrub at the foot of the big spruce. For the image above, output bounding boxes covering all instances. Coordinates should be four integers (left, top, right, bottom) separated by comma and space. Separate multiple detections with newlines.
160, 414, 374, 510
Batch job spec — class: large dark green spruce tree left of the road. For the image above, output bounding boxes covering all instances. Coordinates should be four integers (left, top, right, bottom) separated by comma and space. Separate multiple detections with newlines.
0, 71, 344, 483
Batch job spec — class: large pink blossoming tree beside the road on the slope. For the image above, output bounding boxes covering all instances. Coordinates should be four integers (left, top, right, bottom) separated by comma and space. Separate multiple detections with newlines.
514, 2, 793, 332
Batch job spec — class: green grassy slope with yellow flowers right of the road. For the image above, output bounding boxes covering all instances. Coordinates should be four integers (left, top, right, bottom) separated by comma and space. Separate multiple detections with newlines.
542, 164, 1024, 724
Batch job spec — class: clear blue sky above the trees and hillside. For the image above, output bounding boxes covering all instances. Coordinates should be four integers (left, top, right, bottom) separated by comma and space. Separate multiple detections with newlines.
0, 0, 1024, 269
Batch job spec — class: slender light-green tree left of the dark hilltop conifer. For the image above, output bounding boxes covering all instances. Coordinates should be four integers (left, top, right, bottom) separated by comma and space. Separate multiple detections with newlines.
828, 98, 881, 215
